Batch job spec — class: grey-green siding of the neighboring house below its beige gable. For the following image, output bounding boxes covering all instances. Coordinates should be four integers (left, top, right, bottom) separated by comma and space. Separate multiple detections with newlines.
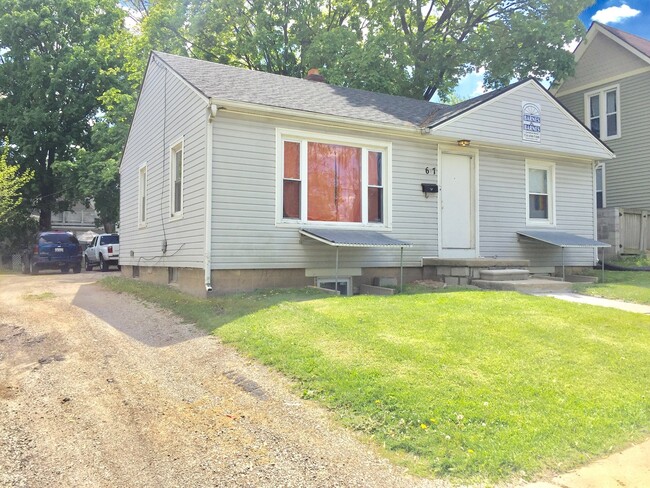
560, 72, 650, 208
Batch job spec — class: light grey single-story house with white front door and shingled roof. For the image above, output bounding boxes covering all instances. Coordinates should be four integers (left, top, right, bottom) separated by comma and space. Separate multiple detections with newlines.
120, 52, 613, 294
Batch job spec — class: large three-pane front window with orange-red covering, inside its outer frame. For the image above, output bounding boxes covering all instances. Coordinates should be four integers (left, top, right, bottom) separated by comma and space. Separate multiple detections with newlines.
278, 132, 388, 224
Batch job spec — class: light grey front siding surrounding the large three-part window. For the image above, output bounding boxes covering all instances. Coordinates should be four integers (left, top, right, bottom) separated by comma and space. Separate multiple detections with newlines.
212, 111, 438, 269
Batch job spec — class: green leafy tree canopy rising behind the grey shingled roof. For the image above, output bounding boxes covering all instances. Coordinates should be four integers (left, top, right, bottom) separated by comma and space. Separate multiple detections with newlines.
125, 0, 591, 99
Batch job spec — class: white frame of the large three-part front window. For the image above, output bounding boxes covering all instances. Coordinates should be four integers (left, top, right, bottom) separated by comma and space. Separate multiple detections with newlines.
276, 129, 392, 230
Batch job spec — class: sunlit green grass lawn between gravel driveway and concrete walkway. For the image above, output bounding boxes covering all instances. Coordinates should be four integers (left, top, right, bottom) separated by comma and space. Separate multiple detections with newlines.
102, 278, 650, 482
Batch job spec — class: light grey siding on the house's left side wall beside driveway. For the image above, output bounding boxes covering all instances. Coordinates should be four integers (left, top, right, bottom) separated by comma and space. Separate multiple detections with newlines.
120, 63, 207, 267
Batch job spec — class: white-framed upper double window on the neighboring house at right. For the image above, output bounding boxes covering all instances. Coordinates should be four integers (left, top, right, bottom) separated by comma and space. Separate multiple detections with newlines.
585, 86, 621, 140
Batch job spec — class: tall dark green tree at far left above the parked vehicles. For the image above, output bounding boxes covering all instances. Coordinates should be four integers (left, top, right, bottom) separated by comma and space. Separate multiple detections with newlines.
0, 0, 125, 229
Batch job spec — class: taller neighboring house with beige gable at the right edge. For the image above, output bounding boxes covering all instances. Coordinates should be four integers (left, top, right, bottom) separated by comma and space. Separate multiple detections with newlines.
551, 22, 650, 209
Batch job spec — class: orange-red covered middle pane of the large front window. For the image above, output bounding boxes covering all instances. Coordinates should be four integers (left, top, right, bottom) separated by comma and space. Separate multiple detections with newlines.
307, 142, 362, 222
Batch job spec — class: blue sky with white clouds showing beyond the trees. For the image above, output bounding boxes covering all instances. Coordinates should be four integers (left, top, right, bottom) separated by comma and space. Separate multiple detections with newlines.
446, 0, 650, 101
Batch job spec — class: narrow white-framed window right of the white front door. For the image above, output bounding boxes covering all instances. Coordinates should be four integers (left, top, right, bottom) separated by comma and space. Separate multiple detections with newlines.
526, 161, 555, 225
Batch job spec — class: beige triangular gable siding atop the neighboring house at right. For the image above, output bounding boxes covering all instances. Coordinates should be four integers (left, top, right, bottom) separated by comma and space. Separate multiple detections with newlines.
556, 34, 648, 98
